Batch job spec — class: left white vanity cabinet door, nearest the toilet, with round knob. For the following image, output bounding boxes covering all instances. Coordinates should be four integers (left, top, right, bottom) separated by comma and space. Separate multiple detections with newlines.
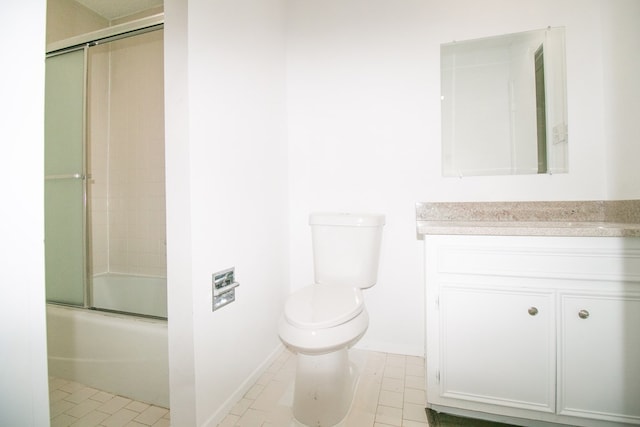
440, 286, 556, 412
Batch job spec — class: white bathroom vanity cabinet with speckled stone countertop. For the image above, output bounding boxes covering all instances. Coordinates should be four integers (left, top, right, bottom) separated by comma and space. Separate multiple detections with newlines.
417, 201, 640, 426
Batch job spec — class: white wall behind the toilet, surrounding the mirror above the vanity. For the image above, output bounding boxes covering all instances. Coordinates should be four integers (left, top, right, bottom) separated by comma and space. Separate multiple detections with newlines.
287, 0, 640, 354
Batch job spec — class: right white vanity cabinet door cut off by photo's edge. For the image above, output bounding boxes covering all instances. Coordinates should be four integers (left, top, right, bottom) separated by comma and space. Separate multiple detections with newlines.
558, 295, 640, 424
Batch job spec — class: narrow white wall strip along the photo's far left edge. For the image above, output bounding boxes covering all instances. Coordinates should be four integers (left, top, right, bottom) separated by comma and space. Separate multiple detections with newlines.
0, 0, 49, 427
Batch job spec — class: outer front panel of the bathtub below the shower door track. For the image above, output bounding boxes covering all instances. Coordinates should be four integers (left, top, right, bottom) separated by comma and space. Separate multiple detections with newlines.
47, 276, 169, 408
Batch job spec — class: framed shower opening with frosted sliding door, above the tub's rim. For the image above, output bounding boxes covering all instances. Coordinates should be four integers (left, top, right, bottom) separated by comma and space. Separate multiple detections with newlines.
45, 22, 167, 318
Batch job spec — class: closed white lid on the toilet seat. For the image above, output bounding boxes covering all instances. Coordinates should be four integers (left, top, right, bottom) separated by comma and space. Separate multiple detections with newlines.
284, 285, 364, 329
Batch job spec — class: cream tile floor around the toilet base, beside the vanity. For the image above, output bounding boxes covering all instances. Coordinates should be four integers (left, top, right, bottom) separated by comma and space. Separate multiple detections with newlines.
219, 349, 427, 427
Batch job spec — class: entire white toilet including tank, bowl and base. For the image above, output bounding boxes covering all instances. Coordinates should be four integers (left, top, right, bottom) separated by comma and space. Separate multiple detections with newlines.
278, 213, 385, 427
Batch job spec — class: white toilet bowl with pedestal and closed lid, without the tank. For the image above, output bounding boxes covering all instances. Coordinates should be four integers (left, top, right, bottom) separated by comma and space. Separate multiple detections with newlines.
279, 284, 369, 426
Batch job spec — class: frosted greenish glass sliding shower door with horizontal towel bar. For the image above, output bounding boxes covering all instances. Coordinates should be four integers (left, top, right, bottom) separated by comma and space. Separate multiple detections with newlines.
45, 48, 87, 306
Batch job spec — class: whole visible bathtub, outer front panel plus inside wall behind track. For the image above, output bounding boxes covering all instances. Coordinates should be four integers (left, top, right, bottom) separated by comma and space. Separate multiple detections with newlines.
47, 274, 169, 408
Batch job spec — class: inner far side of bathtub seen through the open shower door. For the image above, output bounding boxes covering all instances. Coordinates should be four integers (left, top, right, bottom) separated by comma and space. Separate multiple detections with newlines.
93, 273, 167, 318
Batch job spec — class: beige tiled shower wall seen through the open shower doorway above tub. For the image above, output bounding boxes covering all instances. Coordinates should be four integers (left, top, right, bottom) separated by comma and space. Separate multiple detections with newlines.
88, 31, 166, 276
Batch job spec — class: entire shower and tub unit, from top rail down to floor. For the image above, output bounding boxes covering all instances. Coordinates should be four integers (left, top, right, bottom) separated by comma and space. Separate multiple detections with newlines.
45, 15, 169, 407
